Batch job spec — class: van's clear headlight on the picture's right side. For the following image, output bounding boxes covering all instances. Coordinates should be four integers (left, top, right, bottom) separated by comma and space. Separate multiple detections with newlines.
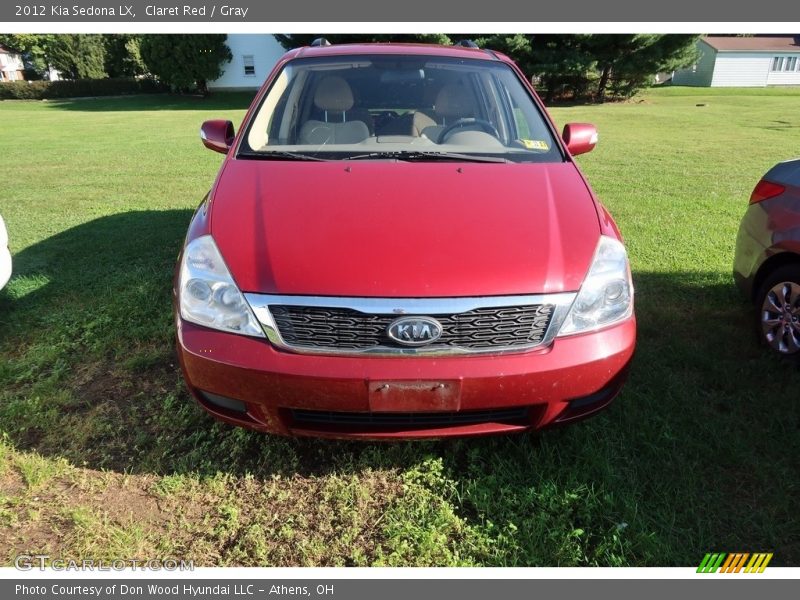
558, 236, 633, 335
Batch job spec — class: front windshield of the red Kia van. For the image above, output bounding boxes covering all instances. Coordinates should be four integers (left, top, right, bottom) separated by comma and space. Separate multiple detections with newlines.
239, 55, 563, 162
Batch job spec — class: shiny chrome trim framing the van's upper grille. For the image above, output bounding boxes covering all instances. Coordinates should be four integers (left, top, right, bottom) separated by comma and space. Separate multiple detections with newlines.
244, 292, 576, 357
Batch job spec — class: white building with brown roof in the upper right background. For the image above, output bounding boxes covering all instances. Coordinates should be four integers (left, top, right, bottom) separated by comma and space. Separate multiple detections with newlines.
672, 35, 800, 87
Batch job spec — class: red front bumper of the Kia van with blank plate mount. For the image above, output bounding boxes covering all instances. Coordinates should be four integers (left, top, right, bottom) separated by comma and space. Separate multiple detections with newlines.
177, 317, 636, 439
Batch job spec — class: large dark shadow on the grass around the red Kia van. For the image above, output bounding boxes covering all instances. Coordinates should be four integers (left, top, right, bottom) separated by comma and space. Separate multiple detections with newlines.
0, 210, 800, 564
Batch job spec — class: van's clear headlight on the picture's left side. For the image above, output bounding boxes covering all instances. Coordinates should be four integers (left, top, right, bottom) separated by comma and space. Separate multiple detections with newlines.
178, 235, 264, 337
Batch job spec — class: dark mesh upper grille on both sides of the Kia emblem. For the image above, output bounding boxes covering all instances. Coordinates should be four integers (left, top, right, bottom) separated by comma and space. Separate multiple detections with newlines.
270, 304, 554, 352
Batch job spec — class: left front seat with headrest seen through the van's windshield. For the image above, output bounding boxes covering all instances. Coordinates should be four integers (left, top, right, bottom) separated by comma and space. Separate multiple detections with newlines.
299, 75, 369, 146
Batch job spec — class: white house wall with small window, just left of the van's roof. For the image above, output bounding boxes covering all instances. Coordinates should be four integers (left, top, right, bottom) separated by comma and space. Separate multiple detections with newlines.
208, 33, 286, 90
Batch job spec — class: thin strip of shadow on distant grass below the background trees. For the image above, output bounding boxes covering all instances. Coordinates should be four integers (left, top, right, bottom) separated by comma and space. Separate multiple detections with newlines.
41, 90, 256, 112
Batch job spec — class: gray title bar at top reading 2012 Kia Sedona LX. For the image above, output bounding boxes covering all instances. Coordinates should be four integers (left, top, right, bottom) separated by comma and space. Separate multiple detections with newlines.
0, 0, 800, 22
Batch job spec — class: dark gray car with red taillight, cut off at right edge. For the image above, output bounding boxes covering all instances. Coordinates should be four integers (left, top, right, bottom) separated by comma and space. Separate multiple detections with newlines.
733, 159, 800, 359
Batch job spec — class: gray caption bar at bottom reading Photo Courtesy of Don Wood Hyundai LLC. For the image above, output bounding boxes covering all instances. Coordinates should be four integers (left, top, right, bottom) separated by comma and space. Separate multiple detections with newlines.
0, 580, 797, 600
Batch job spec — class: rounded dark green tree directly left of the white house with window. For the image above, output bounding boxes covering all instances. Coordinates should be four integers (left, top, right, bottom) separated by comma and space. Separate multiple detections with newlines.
139, 34, 233, 94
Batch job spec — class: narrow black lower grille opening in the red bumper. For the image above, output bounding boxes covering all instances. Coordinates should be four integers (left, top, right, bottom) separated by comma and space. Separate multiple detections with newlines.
289, 406, 531, 429
